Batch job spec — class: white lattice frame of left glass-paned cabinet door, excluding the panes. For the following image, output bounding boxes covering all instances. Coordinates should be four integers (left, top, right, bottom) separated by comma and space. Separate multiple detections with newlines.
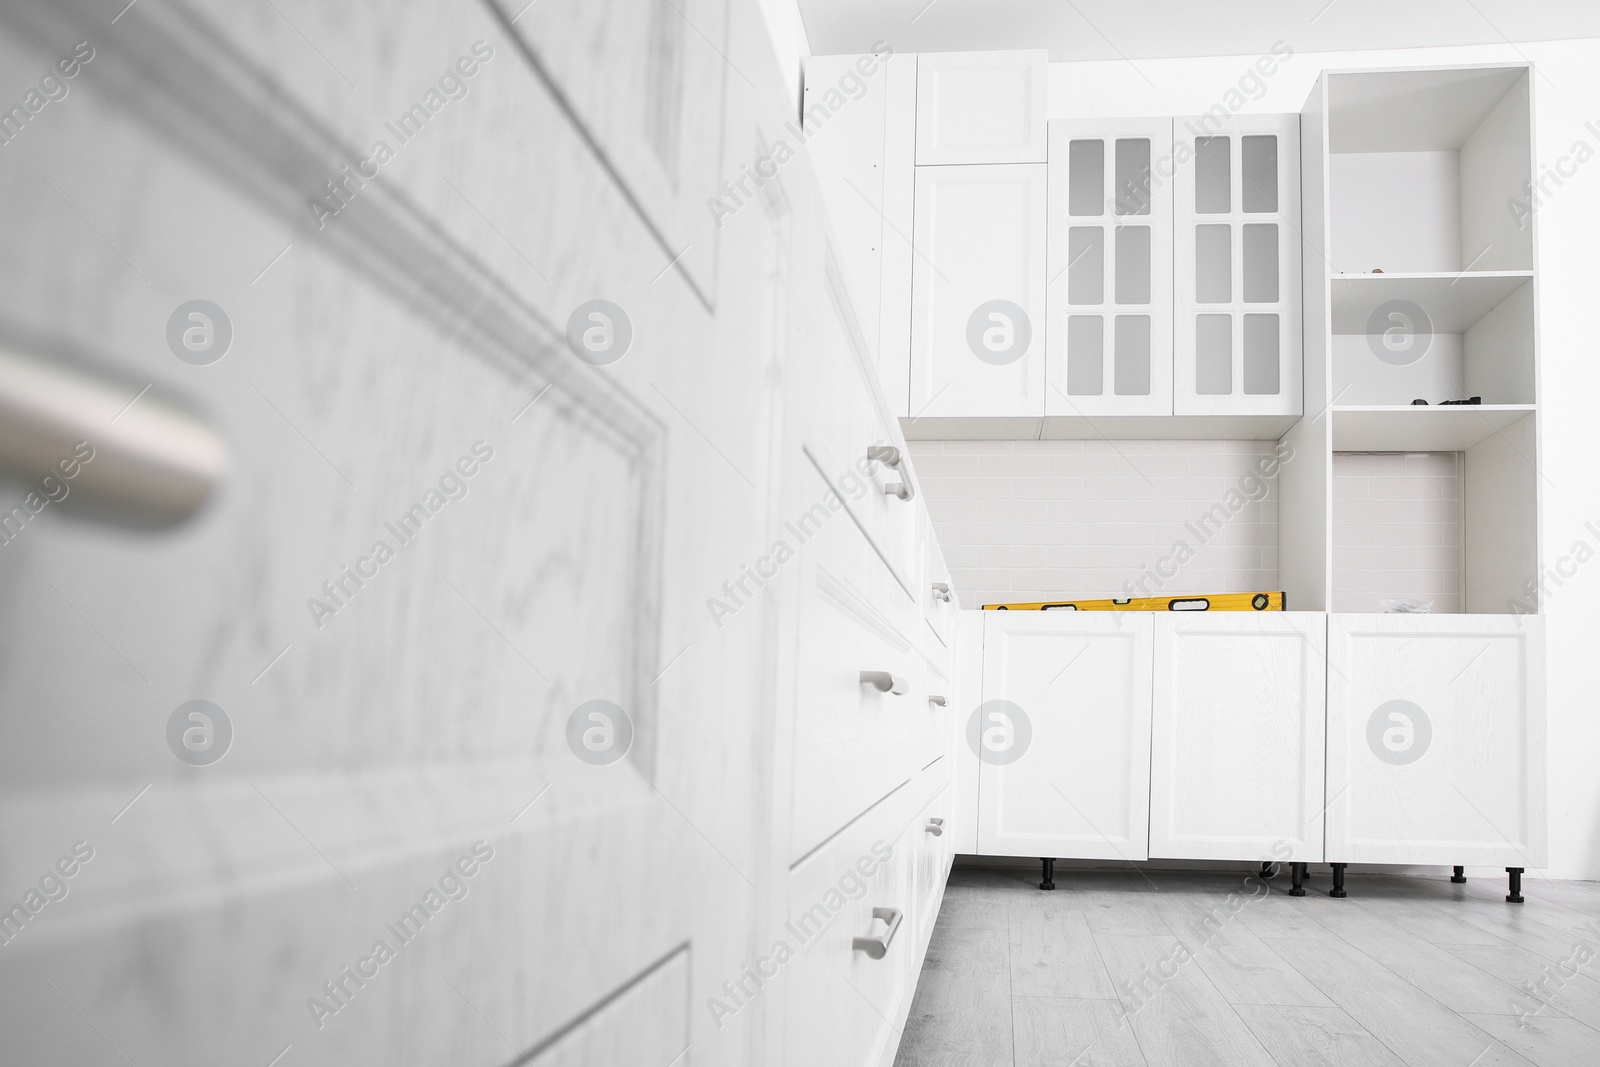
1045, 118, 1173, 416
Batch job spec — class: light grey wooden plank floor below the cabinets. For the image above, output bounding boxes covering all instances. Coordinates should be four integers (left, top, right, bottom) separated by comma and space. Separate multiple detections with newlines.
896, 867, 1600, 1067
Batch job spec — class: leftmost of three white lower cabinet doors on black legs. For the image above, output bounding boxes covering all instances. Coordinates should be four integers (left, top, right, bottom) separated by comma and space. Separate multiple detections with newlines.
965, 611, 1152, 859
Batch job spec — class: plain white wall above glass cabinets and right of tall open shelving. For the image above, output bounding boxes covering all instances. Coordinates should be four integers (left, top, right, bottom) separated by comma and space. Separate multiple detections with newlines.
1050, 40, 1600, 891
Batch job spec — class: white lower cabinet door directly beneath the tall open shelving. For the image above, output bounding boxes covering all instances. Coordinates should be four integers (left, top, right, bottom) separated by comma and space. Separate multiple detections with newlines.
1328, 614, 1546, 867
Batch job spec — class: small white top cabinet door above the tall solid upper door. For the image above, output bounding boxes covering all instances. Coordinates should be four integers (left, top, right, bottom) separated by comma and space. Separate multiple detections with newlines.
917, 50, 1050, 166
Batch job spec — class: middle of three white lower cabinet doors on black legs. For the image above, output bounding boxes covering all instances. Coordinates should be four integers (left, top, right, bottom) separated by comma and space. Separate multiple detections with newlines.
1150, 611, 1328, 862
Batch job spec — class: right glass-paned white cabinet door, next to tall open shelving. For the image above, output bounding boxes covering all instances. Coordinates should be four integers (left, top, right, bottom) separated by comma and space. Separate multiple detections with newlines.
1173, 115, 1302, 414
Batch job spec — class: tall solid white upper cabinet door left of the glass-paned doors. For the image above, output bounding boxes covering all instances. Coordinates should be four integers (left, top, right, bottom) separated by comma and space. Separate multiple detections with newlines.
910, 163, 1045, 419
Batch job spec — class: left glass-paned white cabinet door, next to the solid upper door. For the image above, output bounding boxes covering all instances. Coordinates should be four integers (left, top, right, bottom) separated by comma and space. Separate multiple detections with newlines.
1045, 118, 1173, 416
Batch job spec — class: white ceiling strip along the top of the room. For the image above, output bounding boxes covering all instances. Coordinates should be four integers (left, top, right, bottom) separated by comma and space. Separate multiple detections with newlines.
797, 0, 1600, 61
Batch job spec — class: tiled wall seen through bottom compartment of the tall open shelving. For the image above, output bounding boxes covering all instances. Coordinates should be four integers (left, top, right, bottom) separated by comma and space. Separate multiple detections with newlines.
1333, 453, 1461, 613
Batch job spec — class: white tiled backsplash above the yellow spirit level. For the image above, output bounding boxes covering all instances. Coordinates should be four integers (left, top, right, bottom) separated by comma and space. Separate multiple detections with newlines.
910, 442, 1293, 608
